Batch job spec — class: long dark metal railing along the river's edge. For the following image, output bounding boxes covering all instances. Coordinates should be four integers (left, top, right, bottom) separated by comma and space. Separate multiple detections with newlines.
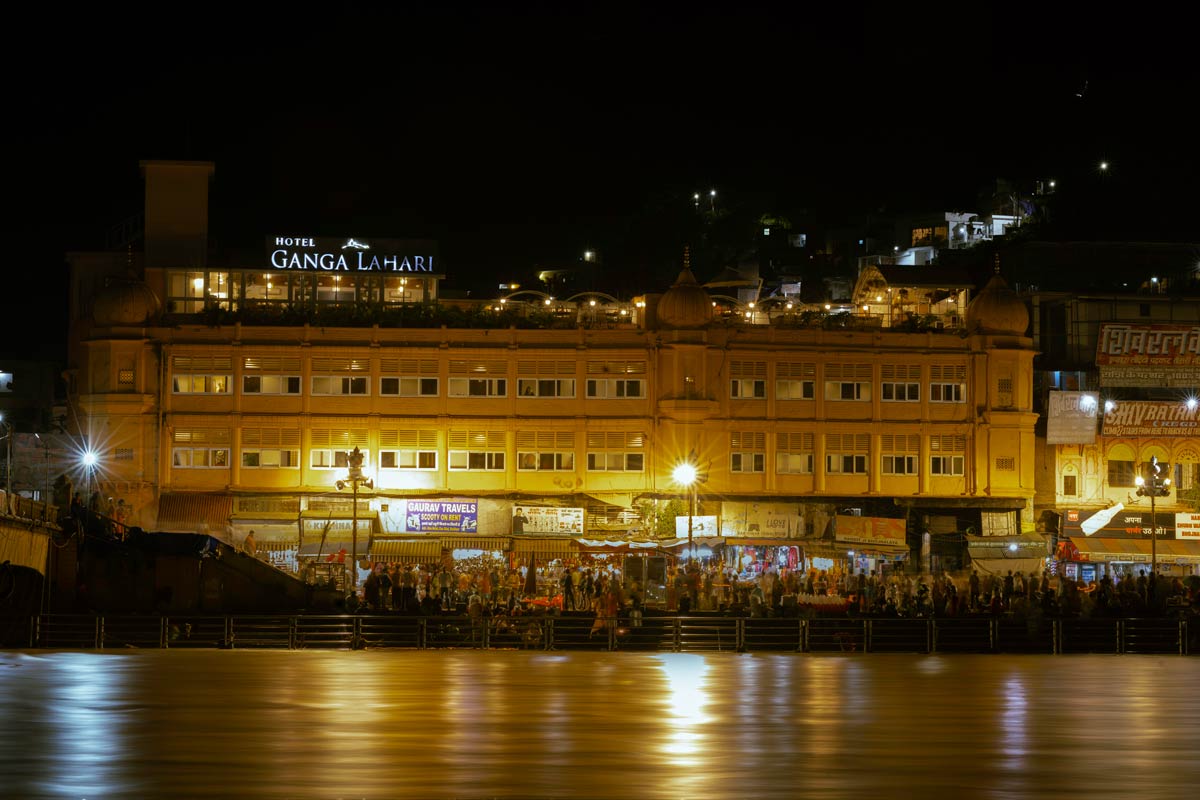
0, 614, 1200, 655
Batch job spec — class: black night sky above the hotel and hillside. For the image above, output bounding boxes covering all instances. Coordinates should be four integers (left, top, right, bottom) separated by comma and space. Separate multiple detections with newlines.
0, 2, 1200, 357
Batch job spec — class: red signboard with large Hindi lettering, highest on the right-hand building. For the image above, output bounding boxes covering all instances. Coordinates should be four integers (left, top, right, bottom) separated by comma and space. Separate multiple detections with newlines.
1096, 323, 1200, 389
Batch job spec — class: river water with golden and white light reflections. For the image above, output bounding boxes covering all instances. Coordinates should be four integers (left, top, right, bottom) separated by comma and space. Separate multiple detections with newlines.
0, 650, 1200, 800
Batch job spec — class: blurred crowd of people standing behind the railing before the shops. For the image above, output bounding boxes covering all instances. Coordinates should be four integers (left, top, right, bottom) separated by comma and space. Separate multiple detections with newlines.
338, 560, 1200, 618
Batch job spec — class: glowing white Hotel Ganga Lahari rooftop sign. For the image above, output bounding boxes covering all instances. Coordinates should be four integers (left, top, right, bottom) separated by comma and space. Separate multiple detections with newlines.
266, 236, 436, 273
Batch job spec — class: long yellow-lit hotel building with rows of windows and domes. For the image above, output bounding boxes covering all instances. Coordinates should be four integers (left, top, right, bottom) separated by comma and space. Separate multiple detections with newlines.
70, 162, 1037, 563
